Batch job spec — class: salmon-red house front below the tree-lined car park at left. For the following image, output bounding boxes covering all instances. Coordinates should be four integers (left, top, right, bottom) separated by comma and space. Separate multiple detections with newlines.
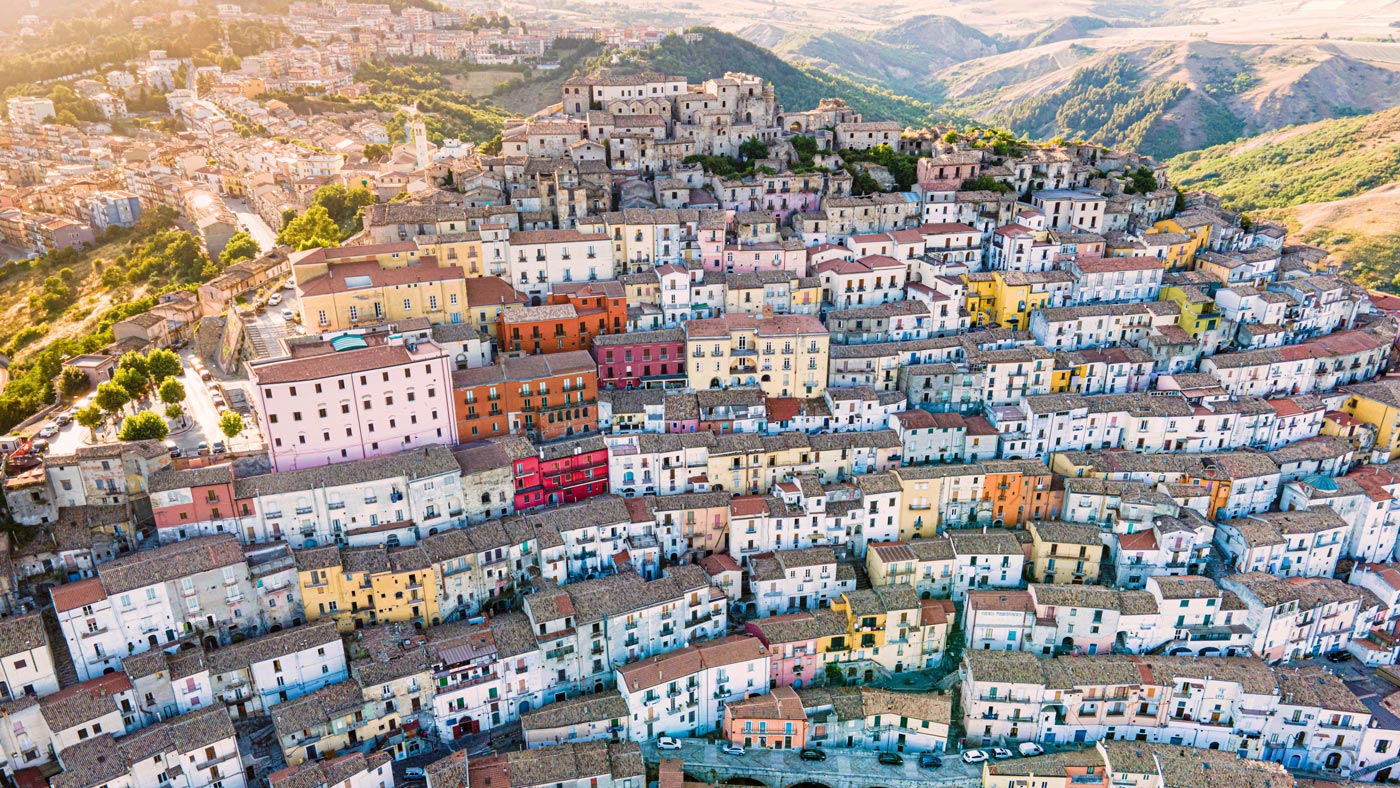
148, 463, 238, 544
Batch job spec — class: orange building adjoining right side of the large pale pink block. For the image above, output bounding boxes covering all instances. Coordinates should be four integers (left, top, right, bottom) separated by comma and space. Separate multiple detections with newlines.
452, 350, 598, 444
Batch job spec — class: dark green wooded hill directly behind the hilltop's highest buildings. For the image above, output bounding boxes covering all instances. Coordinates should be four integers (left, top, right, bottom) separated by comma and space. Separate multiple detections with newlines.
607, 28, 934, 125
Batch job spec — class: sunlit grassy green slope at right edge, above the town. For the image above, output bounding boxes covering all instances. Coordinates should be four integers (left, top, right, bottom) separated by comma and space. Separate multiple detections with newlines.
1168, 109, 1400, 210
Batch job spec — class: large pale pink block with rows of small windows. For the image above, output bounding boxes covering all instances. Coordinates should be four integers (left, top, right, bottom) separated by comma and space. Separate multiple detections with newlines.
252, 333, 456, 470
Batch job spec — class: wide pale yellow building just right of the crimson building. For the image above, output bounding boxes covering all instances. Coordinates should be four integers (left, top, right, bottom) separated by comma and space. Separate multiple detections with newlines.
686, 315, 830, 397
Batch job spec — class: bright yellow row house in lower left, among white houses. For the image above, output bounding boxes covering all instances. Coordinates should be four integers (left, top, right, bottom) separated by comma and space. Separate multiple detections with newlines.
297, 546, 438, 633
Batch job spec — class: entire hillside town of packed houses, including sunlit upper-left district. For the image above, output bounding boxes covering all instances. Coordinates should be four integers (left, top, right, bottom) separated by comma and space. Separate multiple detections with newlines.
0, 1, 1400, 788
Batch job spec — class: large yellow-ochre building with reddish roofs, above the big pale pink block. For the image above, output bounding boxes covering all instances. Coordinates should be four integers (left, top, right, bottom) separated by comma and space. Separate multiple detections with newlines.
291, 241, 468, 330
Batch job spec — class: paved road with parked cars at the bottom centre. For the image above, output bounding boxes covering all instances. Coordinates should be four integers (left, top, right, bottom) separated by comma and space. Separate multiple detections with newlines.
641, 739, 981, 788
